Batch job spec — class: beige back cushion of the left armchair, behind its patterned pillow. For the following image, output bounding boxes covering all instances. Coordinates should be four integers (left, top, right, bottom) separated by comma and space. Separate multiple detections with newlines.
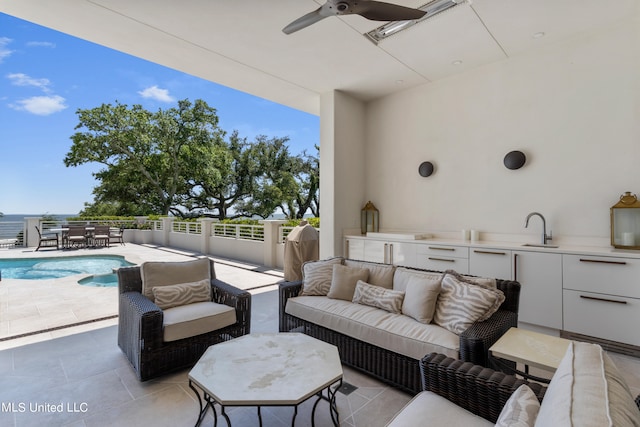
140, 258, 210, 301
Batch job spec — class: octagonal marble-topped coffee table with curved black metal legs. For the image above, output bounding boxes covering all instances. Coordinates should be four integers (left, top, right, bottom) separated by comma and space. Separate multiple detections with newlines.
189, 333, 342, 426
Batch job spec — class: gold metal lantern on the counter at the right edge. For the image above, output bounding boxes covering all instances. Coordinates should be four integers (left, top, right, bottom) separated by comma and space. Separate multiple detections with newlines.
611, 191, 640, 249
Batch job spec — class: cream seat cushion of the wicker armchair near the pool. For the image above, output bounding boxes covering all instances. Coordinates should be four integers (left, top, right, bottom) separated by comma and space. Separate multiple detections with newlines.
162, 301, 236, 342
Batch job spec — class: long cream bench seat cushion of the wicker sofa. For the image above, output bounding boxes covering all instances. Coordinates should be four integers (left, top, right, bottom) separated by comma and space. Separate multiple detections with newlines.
285, 296, 460, 360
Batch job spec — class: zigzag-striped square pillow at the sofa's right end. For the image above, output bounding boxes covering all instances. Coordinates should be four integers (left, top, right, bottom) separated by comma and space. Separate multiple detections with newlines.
433, 273, 504, 334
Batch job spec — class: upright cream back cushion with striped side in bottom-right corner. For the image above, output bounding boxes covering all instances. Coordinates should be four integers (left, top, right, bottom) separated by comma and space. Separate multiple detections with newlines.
535, 342, 640, 427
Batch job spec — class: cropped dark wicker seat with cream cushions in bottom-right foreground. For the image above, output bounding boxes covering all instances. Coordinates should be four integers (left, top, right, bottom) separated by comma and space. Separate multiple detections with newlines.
388, 342, 640, 427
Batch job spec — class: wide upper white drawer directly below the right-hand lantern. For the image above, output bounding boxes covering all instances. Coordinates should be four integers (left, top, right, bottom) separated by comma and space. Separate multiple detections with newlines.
562, 255, 640, 298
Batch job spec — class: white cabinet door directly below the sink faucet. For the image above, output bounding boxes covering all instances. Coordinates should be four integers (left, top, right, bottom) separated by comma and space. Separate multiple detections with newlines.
513, 251, 562, 329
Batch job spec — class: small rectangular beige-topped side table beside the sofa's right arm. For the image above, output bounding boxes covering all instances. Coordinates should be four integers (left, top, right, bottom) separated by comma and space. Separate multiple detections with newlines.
489, 328, 570, 383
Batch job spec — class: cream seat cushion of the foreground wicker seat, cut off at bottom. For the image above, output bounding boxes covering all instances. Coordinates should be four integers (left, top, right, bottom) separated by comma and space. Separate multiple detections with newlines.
387, 391, 493, 427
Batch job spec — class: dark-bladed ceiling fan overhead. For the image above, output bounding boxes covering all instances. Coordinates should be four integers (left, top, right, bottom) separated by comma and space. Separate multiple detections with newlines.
282, 0, 426, 34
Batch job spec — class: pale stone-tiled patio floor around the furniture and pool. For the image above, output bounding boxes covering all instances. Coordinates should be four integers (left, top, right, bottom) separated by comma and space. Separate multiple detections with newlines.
0, 244, 640, 427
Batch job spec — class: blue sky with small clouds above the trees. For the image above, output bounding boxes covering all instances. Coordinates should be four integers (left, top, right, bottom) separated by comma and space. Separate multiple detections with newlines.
0, 13, 320, 215
